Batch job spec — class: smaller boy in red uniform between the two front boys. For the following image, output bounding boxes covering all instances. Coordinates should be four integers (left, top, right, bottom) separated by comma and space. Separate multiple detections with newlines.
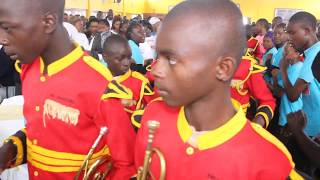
103, 35, 154, 126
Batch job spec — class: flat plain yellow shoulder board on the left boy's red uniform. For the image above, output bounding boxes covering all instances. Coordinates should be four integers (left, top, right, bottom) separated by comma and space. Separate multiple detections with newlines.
83, 56, 113, 81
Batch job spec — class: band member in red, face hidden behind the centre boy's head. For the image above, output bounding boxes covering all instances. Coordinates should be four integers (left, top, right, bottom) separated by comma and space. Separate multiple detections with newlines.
231, 56, 276, 127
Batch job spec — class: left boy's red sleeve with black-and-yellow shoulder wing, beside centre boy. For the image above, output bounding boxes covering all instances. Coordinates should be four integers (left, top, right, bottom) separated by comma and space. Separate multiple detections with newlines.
96, 82, 136, 180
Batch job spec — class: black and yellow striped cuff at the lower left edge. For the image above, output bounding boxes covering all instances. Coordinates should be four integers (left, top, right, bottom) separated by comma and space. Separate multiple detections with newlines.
4, 129, 27, 167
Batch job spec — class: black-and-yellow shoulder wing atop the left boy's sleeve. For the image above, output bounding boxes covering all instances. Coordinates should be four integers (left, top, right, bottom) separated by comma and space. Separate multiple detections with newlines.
102, 80, 133, 100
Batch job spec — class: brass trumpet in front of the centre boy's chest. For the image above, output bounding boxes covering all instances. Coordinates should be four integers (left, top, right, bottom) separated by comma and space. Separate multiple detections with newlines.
137, 121, 166, 180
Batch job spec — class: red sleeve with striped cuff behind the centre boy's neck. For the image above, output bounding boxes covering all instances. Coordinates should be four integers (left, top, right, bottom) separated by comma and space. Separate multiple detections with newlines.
246, 65, 276, 127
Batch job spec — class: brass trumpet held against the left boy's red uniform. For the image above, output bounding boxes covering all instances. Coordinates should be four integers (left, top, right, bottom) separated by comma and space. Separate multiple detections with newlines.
74, 127, 112, 180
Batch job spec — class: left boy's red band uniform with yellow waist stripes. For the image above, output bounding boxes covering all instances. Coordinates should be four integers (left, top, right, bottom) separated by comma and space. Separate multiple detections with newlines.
8, 46, 135, 180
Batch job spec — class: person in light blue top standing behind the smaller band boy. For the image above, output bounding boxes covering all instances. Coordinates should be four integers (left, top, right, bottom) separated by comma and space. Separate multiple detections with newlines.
127, 21, 146, 74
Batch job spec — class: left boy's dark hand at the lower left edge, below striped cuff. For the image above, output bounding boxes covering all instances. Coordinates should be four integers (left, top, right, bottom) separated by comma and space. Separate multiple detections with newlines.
0, 142, 17, 174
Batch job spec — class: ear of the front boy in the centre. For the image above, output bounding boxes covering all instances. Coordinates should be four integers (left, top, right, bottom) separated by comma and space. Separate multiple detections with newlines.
216, 57, 237, 82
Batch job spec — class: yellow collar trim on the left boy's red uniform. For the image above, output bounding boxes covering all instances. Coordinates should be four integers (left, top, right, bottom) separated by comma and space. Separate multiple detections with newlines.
40, 45, 83, 76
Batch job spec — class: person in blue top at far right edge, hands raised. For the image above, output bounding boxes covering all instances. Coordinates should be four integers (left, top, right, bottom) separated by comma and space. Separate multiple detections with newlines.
281, 12, 320, 173
